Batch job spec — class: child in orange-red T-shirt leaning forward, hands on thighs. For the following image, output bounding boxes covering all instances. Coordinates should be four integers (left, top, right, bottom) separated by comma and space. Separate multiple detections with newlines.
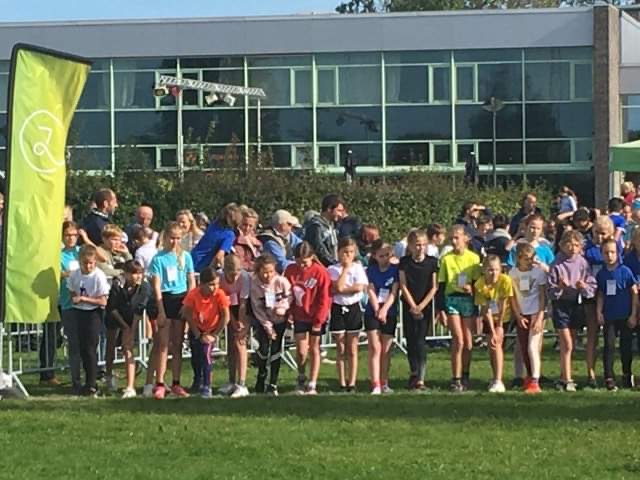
182, 267, 229, 398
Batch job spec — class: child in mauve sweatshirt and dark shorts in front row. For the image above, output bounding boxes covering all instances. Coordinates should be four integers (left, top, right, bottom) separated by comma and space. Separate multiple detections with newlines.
547, 230, 597, 392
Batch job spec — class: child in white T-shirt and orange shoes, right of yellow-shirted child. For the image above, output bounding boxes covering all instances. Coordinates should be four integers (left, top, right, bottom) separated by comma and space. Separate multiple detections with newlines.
509, 243, 547, 393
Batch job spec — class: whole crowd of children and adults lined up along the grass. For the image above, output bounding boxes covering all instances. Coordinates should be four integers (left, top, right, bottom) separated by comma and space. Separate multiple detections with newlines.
47, 188, 640, 399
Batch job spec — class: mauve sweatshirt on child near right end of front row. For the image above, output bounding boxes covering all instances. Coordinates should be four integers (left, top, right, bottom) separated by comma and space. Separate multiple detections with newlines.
547, 255, 598, 301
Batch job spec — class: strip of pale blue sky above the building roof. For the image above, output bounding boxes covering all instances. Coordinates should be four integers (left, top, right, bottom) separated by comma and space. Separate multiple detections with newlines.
5, 0, 340, 22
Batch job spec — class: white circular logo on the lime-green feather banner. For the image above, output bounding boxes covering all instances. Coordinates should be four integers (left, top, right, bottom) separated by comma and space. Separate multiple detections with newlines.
19, 110, 64, 174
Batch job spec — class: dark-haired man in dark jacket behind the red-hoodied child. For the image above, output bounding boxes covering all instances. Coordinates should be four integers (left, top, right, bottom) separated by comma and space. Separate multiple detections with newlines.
304, 193, 346, 267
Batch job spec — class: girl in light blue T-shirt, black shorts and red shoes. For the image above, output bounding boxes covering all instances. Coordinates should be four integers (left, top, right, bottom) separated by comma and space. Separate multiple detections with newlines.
149, 222, 195, 400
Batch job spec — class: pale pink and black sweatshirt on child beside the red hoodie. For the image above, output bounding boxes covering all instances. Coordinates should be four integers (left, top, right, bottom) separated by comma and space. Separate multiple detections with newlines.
249, 275, 291, 333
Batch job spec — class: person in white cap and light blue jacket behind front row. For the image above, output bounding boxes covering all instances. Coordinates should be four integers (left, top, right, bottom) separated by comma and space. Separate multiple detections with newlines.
258, 210, 302, 273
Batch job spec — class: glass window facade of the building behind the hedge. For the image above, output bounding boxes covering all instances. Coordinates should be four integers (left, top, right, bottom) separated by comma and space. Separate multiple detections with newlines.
0, 47, 592, 181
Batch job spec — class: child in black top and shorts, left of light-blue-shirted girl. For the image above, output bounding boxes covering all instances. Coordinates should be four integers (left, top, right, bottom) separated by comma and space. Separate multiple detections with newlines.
105, 260, 156, 398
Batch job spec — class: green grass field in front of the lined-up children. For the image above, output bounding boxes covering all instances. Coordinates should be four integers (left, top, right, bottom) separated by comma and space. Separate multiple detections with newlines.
0, 348, 640, 480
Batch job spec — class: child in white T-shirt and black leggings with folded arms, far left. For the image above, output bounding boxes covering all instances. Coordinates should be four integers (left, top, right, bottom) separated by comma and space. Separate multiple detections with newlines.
67, 245, 109, 397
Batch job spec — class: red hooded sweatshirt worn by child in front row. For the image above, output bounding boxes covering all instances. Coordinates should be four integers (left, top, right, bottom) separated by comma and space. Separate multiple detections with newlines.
284, 261, 331, 328
